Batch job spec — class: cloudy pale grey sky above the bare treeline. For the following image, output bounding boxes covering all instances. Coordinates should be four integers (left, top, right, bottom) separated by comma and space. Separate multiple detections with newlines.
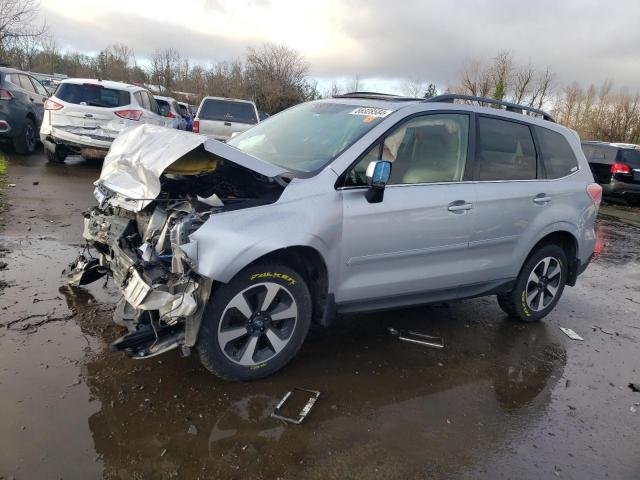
41, 0, 640, 91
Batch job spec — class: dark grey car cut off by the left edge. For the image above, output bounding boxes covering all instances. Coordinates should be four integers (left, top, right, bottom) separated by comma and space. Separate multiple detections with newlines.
0, 67, 49, 154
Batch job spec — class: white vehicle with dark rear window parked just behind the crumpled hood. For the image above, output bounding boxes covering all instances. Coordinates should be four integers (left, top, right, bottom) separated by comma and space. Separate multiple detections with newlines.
193, 97, 260, 141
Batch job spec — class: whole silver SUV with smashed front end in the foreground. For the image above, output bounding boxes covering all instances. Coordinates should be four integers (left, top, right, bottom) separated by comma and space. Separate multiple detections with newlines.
69, 94, 602, 380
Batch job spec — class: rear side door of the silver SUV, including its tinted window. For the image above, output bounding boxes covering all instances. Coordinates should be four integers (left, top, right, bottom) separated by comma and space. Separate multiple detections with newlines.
466, 115, 550, 285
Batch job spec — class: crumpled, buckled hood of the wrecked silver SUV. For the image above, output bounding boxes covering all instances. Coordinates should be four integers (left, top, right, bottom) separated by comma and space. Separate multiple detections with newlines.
96, 124, 287, 211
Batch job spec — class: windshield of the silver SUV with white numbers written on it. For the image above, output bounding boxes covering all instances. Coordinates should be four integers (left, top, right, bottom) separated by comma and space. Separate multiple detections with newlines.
227, 102, 392, 173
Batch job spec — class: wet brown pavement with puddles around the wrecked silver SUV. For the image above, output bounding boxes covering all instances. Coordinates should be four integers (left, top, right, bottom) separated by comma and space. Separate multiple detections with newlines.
0, 148, 640, 480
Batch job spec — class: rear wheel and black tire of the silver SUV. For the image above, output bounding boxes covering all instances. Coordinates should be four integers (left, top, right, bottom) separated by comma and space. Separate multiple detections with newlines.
497, 244, 568, 322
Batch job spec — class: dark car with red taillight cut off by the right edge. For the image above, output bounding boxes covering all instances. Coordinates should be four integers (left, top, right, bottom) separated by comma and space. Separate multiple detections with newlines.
582, 142, 640, 205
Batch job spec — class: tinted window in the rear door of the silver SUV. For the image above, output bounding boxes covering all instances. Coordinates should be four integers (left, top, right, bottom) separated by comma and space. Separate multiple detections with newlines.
477, 117, 536, 180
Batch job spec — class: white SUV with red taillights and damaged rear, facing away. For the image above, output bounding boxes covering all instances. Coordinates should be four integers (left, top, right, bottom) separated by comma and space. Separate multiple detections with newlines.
40, 78, 166, 162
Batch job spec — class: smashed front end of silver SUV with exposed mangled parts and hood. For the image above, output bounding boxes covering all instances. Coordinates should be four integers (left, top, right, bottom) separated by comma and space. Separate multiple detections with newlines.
67, 126, 285, 358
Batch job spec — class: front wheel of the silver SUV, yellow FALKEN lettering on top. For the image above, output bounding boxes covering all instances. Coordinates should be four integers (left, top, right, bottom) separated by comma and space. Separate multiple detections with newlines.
197, 262, 311, 381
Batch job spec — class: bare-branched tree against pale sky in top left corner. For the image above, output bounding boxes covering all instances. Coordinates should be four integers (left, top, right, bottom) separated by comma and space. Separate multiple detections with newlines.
0, 0, 47, 61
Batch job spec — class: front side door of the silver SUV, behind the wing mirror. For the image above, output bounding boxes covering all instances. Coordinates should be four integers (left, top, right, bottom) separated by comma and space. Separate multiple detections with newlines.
336, 112, 475, 311
